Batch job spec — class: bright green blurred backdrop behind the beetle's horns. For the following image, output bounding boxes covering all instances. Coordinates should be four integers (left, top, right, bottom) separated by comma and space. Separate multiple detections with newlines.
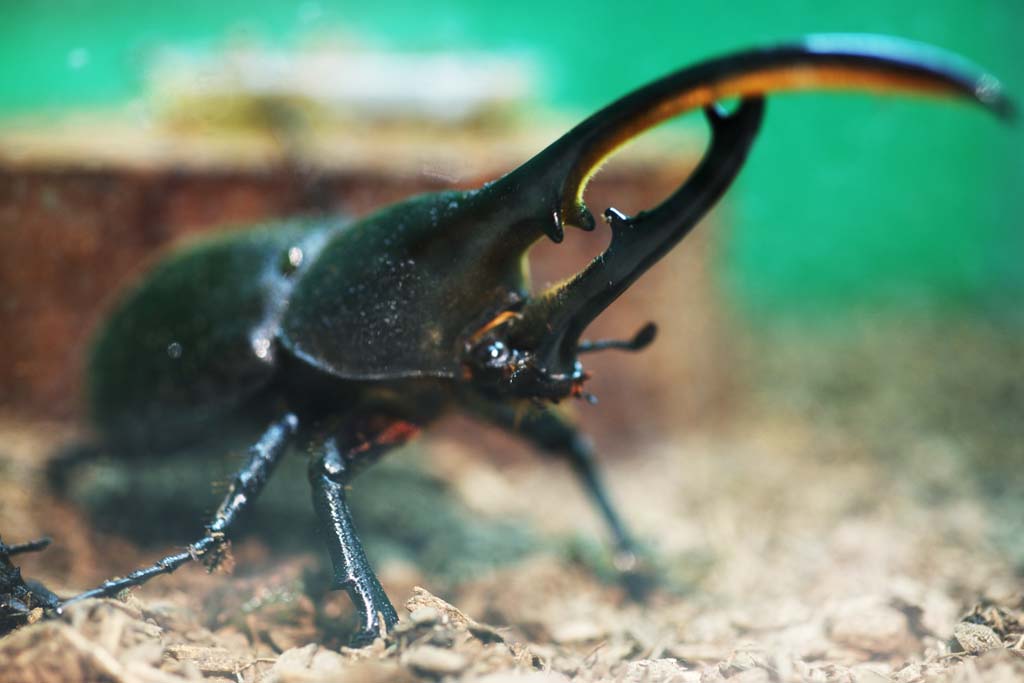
0, 0, 1024, 321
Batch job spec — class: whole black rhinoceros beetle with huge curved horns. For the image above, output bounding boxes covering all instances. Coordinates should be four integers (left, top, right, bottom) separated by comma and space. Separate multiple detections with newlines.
12, 36, 1012, 644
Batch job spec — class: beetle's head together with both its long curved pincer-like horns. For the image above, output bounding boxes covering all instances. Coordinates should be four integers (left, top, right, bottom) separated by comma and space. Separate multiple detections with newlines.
462, 36, 1013, 400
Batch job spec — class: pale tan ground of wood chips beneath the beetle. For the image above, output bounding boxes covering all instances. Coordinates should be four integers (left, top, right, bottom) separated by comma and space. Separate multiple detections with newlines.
0, 317, 1024, 683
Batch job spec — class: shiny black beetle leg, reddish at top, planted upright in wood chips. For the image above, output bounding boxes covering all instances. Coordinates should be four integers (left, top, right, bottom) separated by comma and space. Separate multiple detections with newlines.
309, 419, 419, 647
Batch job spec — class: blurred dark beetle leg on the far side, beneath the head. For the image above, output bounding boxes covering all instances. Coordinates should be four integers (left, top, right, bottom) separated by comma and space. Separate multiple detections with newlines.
469, 402, 651, 599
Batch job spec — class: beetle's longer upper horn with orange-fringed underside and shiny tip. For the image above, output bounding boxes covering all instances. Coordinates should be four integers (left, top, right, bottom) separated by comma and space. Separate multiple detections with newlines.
495, 35, 1014, 242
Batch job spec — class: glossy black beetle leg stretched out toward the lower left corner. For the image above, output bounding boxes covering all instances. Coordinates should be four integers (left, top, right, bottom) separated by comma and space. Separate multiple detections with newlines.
60, 414, 299, 607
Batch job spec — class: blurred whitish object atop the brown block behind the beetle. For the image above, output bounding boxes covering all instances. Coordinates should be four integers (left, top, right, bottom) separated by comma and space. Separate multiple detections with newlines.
147, 47, 532, 129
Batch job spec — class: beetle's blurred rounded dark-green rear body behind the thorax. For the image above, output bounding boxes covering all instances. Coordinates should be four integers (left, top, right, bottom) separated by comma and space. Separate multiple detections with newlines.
87, 219, 344, 450
